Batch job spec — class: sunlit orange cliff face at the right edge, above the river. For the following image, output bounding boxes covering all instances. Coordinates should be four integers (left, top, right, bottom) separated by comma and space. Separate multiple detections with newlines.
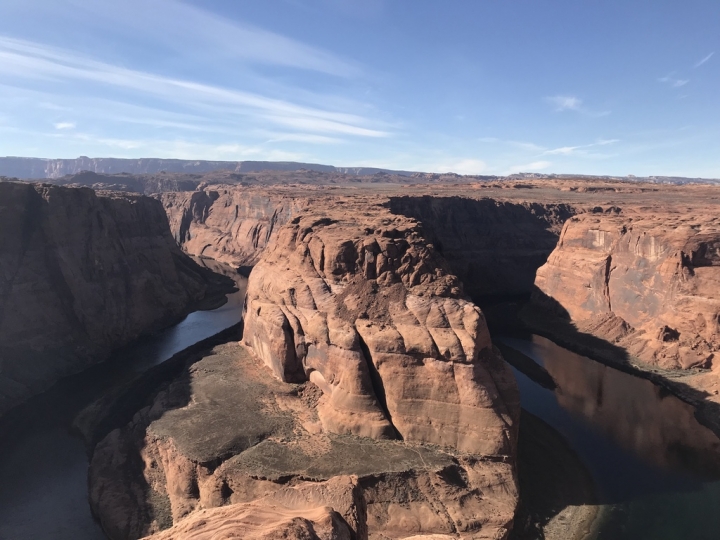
535, 213, 720, 369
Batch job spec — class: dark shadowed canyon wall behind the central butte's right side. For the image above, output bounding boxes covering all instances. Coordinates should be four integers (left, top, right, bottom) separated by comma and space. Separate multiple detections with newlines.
389, 195, 577, 298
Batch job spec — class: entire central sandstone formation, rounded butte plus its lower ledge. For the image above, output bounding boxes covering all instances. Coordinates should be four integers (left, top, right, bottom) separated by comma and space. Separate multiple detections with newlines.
90, 199, 519, 540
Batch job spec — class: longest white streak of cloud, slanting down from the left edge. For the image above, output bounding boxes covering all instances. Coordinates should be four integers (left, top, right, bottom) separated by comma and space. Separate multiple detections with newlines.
0, 36, 390, 137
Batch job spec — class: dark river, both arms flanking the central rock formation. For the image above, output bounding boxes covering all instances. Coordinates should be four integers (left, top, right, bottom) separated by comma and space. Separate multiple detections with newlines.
0, 281, 720, 540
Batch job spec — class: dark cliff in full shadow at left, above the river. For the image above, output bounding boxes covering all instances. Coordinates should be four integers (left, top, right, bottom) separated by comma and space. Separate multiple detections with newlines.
0, 182, 226, 413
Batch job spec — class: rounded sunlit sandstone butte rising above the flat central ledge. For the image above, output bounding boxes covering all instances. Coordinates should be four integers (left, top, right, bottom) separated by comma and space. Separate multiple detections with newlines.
244, 205, 517, 457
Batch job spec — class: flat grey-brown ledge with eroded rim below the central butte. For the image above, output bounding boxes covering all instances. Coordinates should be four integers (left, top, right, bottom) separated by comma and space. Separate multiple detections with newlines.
90, 342, 517, 540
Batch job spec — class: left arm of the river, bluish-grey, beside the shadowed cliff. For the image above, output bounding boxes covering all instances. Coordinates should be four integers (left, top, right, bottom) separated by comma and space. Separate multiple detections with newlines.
0, 278, 245, 540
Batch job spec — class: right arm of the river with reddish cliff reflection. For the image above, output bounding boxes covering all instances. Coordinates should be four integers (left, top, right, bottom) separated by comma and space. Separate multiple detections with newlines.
504, 336, 720, 540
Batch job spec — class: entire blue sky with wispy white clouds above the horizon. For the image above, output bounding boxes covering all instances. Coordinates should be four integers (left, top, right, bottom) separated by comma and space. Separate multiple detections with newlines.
0, 0, 720, 177
